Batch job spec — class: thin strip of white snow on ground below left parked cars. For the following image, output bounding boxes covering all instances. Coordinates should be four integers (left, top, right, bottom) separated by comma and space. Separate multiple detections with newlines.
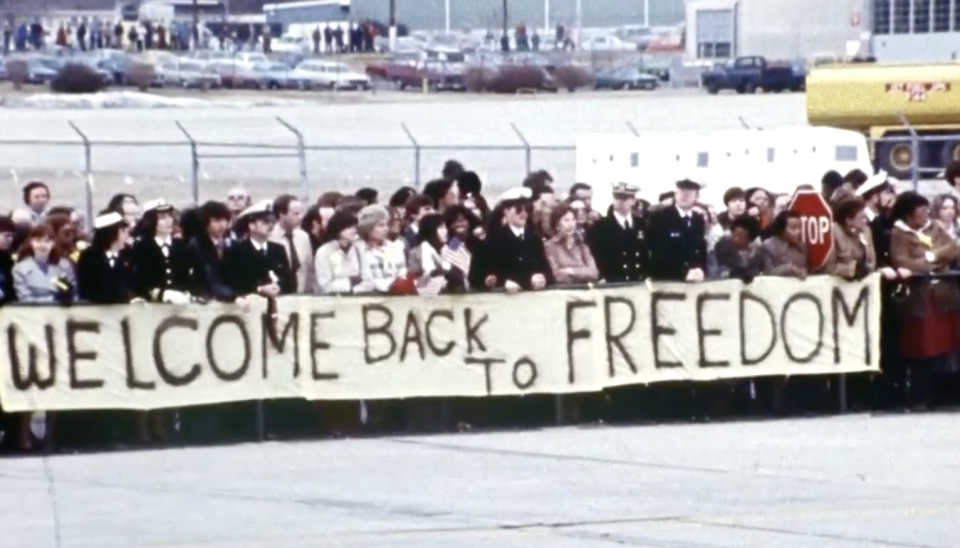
0, 91, 305, 110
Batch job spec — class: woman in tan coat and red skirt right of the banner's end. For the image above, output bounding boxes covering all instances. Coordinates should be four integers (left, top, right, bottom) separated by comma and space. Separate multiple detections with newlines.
890, 192, 960, 366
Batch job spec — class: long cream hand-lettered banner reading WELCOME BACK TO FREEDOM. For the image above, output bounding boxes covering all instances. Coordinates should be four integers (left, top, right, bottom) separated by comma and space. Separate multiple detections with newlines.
0, 276, 880, 411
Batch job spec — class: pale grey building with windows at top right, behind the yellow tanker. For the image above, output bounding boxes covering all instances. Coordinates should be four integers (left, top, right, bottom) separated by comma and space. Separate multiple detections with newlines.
686, 0, 960, 62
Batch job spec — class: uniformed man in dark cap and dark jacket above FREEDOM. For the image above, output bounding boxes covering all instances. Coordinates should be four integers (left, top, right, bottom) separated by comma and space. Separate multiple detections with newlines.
647, 179, 707, 282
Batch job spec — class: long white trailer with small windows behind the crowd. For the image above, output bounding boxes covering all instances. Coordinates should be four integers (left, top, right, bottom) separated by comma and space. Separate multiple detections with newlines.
576, 126, 873, 212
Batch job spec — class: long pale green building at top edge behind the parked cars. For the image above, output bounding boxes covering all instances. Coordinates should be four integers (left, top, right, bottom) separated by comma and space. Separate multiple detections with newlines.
264, 0, 684, 30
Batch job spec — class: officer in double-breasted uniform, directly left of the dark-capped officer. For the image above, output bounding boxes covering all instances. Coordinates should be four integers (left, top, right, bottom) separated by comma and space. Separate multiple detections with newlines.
587, 183, 647, 282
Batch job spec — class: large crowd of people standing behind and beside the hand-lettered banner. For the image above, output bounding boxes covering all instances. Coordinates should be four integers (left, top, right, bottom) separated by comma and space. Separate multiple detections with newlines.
0, 160, 960, 450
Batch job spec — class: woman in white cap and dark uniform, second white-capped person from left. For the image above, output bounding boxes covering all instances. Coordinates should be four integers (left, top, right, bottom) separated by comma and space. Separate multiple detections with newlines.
130, 199, 190, 304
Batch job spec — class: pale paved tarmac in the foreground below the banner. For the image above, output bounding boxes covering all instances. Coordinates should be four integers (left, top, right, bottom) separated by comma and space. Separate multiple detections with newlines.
0, 414, 960, 548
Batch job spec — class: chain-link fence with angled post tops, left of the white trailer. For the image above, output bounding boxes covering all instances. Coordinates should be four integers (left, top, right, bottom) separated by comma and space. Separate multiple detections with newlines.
0, 117, 592, 220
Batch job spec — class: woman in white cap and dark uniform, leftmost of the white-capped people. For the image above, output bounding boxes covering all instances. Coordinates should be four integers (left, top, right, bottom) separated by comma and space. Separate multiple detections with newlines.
77, 211, 136, 304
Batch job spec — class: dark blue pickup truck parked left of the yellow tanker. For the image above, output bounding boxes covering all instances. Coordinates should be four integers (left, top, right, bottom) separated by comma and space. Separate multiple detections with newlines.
700, 56, 806, 95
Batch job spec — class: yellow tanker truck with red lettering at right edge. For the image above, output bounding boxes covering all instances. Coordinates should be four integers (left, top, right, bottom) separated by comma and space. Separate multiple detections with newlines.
807, 63, 960, 179
